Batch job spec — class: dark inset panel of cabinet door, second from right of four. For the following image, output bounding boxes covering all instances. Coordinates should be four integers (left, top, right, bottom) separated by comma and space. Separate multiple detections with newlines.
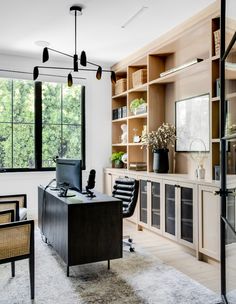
165, 184, 176, 236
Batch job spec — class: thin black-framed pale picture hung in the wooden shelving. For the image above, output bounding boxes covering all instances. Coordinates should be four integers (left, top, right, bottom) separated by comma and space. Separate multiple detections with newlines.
175, 94, 210, 152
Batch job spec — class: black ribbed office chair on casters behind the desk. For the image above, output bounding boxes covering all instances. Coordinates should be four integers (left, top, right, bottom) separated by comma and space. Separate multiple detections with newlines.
112, 178, 139, 252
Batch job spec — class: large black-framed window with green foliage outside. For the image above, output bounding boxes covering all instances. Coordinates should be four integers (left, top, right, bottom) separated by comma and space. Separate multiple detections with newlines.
0, 79, 85, 171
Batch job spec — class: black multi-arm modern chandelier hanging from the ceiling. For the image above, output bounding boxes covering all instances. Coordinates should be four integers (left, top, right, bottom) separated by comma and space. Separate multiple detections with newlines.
33, 5, 116, 87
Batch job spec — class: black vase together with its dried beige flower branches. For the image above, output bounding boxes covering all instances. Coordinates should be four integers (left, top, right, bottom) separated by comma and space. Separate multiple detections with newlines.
141, 123, 176, 173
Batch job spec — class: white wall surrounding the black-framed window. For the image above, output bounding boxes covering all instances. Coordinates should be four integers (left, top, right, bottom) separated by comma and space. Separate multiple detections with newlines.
0, 55, 111, 218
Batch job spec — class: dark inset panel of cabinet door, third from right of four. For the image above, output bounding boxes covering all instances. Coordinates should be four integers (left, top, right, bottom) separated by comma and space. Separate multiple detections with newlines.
151, 182, 161, 229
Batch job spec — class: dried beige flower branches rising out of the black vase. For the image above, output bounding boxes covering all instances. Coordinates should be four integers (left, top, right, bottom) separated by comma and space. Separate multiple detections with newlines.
141, 123, 176, 152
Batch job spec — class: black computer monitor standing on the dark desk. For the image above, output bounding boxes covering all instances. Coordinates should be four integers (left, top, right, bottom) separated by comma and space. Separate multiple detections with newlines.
56, 158, 82, 192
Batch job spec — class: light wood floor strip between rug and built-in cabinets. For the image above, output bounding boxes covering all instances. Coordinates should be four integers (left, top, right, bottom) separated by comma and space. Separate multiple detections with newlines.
123, 220, 220, 293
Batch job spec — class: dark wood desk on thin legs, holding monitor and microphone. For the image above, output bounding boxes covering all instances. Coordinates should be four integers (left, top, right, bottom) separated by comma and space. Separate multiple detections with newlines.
38, 186, 122, 276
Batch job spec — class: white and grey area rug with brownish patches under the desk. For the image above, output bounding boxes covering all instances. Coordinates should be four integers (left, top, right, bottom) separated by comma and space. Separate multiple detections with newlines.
0, 231, 220, 304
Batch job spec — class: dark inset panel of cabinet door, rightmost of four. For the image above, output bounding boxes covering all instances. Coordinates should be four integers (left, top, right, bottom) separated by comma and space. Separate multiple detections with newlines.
179, 187, 193, 243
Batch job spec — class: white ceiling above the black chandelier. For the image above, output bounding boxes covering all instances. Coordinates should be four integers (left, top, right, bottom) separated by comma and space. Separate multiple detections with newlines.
0, 0, 215, 65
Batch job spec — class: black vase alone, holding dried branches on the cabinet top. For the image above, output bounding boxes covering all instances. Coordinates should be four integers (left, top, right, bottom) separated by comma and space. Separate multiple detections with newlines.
153, 149, 169, 173
